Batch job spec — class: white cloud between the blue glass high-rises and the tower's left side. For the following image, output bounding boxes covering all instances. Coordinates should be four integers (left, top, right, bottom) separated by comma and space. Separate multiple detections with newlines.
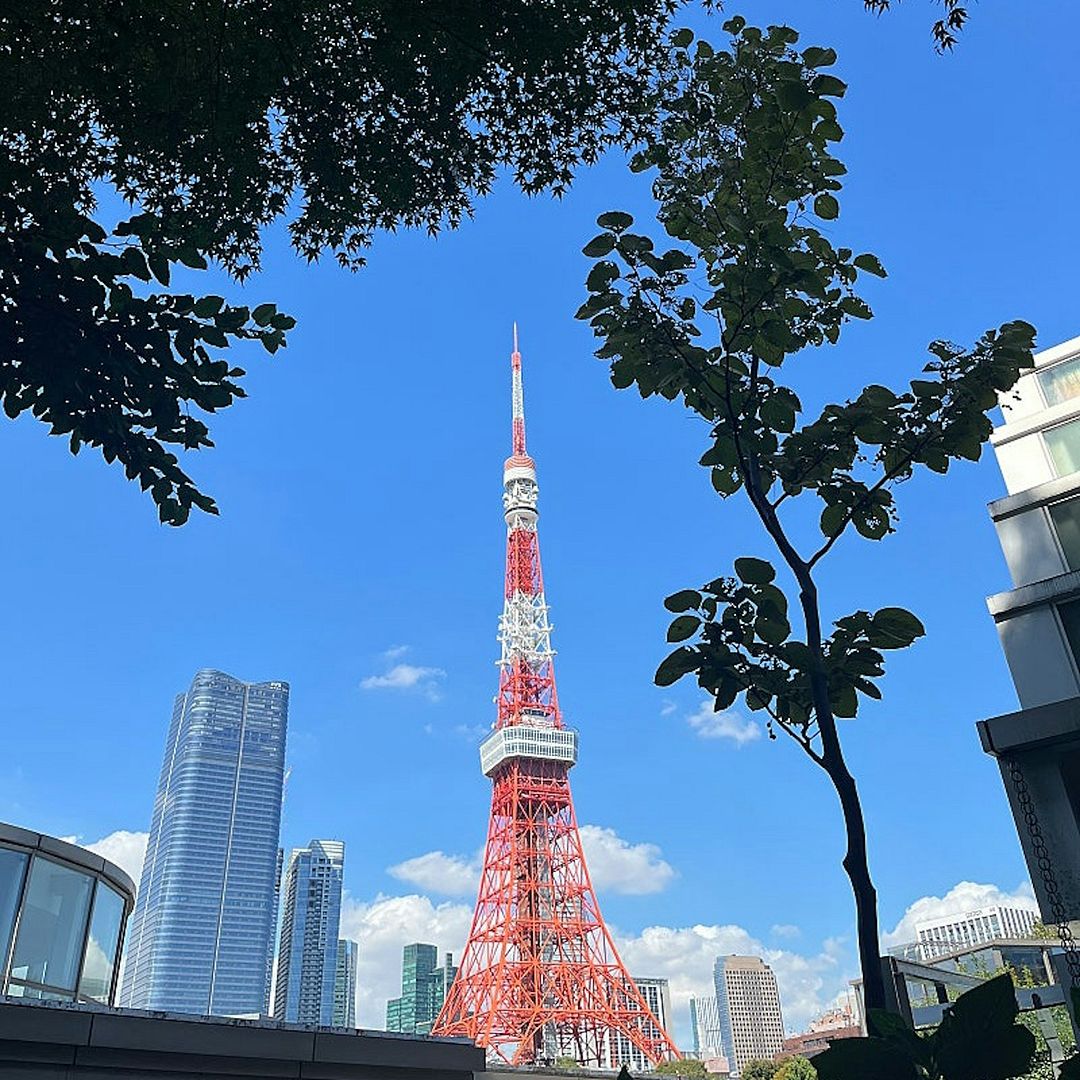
340, 894, 472, 1030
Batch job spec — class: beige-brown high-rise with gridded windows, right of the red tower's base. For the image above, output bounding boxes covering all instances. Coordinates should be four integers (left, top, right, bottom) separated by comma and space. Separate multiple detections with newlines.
713, 956, 784, 1074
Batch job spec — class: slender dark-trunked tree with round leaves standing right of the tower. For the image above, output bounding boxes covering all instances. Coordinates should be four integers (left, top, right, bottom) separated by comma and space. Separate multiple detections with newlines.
578, 18, 1035, 1008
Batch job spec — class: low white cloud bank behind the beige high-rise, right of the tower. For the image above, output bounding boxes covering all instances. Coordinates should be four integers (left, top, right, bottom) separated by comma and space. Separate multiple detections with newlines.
615, 926, 856, 1045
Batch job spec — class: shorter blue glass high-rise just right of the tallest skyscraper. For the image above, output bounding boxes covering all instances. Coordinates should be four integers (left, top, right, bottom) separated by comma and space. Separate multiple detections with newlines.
273, 840, 345, 1024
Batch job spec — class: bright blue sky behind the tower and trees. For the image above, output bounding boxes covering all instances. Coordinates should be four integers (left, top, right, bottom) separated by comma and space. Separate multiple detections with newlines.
0, 0, 1080, 1038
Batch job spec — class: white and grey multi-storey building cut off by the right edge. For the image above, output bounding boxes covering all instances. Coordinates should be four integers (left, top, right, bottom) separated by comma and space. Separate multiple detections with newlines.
980, 338, 1080, 923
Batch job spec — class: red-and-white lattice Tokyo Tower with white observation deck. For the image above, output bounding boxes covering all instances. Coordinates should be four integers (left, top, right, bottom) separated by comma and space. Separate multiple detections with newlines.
432, 326, 678, 1068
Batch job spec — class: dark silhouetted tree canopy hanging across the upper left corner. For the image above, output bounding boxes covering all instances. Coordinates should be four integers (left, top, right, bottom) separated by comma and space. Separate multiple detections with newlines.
0, 0, 674, 525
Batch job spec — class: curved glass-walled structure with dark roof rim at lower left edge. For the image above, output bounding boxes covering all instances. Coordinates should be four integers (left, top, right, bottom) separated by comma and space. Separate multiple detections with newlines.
0, 831, 133, 1004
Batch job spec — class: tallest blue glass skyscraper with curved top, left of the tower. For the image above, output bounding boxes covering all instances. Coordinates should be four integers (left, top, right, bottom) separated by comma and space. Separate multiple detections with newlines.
120, 670, 288, 1015
